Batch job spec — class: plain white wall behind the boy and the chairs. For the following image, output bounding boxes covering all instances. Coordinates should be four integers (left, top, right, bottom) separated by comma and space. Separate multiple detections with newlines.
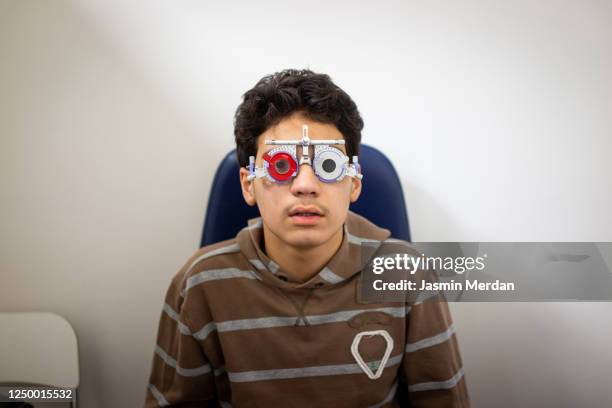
0, 0, 612, 408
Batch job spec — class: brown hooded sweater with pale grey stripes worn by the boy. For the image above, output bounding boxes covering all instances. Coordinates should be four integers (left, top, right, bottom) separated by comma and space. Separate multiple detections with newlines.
145, 213, 469, 408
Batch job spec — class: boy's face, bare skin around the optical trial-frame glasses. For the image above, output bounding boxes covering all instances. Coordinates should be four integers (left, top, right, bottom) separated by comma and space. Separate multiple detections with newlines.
240, 113, 361, 248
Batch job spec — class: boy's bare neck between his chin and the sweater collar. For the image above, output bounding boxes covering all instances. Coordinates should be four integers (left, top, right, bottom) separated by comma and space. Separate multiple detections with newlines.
264, 228, 344, 282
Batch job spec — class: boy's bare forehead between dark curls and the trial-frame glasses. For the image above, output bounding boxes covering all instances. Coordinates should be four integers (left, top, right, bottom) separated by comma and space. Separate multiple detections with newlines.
257, 113, 346, 154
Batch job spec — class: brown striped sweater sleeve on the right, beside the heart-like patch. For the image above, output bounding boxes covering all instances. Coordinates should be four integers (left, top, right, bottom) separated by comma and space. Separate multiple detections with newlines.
400, 284, 470, 408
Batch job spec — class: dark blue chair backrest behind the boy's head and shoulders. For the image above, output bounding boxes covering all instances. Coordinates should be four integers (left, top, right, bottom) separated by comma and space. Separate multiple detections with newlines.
200, 145, 410, 246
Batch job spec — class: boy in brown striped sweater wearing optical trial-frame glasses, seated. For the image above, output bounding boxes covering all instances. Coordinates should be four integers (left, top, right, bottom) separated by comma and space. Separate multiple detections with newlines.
146, 70, 469, 407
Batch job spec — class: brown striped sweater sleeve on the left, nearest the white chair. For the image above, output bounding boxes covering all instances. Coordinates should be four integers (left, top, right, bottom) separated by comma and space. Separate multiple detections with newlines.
144, 275, 219, 408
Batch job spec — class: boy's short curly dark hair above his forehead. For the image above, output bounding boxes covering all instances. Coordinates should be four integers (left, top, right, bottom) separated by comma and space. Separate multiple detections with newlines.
234, 69, 363, 166
